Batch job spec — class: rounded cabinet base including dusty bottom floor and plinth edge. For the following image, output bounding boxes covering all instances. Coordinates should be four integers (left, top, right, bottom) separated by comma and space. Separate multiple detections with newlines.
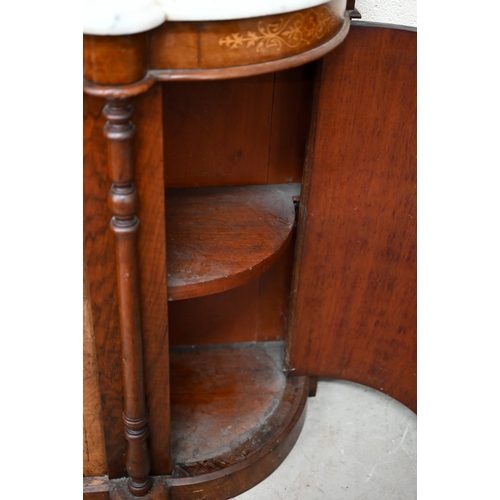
85, 342, 309, 500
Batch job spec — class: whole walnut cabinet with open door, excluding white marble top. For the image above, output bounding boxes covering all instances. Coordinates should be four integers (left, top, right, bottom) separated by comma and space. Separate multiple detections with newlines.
84, 2, 416, 499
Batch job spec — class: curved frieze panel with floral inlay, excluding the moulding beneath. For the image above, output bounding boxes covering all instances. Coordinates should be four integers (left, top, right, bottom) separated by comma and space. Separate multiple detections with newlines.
150, 1, 345, 69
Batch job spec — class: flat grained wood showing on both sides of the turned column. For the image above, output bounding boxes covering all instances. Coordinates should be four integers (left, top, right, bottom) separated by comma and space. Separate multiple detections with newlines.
84, 87, 170, 478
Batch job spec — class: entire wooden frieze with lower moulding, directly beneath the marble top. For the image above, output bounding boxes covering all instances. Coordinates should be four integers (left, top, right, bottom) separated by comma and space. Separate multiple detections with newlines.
84, 0, 353, 98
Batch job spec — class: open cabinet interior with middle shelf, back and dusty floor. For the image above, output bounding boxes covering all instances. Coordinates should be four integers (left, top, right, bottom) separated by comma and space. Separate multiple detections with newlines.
162, 64, 314, 472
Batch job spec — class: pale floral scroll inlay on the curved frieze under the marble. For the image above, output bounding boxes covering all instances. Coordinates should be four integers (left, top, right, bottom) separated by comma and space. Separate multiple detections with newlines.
219, 7, 335, 52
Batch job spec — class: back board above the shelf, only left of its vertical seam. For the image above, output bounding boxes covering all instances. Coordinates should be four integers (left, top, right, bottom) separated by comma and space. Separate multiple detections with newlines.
163, 74, 274, 187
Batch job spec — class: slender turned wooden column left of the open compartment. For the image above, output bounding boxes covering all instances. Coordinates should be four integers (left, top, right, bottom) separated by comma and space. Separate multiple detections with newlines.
103, 99, 151, 496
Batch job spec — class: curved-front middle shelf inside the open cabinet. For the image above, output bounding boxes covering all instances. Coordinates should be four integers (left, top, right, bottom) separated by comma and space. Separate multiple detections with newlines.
165, 184, 300, 300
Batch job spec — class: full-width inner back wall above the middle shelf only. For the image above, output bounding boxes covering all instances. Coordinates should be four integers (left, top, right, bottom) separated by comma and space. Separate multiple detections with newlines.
163, 64, 314, 187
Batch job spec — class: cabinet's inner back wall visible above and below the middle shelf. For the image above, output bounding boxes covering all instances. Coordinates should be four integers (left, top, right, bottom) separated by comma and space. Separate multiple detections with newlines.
163, 63, 315, 345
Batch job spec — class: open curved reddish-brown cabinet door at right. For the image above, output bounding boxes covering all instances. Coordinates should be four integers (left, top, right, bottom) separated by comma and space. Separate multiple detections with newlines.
288, 27, 416, 411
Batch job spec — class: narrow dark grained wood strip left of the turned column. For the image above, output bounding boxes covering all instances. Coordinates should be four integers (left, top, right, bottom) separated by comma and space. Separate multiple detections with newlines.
83, 95, 126, 478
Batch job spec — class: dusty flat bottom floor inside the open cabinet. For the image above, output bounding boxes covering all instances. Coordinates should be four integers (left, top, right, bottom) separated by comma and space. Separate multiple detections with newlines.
171, 342, 286, 464
